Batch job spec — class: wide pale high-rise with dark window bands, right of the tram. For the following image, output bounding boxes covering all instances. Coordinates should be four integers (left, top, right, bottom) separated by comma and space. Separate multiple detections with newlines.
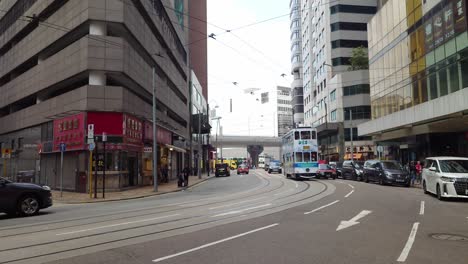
301, 0, 377, 160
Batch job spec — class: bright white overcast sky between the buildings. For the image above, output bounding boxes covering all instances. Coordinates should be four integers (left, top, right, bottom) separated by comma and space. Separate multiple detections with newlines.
207, 0, 292, 136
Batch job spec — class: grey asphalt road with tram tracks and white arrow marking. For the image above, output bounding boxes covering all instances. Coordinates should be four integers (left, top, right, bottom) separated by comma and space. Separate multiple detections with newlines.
0, 170, 468, 264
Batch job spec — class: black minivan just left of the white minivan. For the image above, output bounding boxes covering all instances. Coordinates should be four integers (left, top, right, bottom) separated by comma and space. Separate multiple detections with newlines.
364, 160, 411, 187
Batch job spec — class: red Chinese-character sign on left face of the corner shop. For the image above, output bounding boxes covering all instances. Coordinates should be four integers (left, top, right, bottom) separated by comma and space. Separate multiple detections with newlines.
52, 113, 85, 152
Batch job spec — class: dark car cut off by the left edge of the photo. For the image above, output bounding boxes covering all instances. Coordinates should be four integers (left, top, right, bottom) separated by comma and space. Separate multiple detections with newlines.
0, 177, 52, 216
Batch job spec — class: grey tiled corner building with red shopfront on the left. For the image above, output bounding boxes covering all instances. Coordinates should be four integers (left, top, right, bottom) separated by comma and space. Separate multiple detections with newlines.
0, 0, 190, 192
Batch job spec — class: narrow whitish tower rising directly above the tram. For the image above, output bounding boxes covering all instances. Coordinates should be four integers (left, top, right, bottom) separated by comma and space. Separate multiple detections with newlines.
289, 0, 304, 125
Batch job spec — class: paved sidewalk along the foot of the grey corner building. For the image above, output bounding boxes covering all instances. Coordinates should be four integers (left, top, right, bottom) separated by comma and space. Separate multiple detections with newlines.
52, 174, 213, 204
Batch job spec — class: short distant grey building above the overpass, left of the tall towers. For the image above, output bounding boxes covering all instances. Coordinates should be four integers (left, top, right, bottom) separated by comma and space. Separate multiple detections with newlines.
276, 86, 294, 137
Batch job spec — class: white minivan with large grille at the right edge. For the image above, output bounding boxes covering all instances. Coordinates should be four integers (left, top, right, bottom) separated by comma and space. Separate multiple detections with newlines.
422, 157, 468, 200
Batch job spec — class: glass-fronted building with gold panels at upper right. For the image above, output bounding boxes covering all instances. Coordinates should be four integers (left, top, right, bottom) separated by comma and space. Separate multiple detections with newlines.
359, 0, 468, 163
